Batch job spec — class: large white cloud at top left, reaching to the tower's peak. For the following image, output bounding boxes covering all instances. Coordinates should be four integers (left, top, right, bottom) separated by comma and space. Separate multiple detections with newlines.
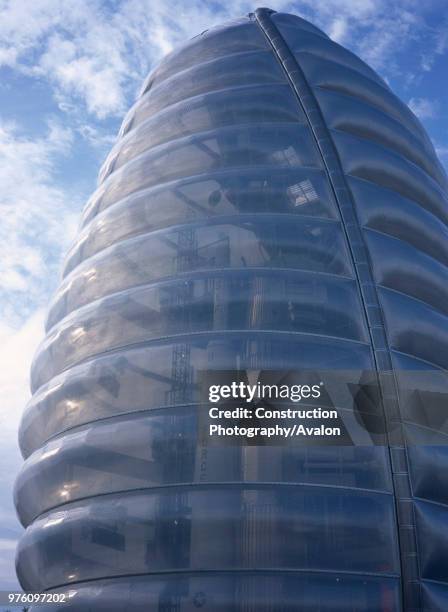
0, 0, 251, 119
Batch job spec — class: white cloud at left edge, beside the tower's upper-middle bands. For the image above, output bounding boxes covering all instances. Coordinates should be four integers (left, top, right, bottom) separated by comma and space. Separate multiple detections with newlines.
0, 121, 77, 325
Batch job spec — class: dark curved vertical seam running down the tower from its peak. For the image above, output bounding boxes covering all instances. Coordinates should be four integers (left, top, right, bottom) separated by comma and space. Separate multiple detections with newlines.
254, 8, 421, 612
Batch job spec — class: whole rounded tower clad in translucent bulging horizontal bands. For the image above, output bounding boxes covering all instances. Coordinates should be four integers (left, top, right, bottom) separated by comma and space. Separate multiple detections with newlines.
15, 9, 448, 612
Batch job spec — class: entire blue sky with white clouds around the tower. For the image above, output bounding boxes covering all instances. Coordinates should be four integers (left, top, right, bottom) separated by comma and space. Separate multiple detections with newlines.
0, 0, 448, 589
